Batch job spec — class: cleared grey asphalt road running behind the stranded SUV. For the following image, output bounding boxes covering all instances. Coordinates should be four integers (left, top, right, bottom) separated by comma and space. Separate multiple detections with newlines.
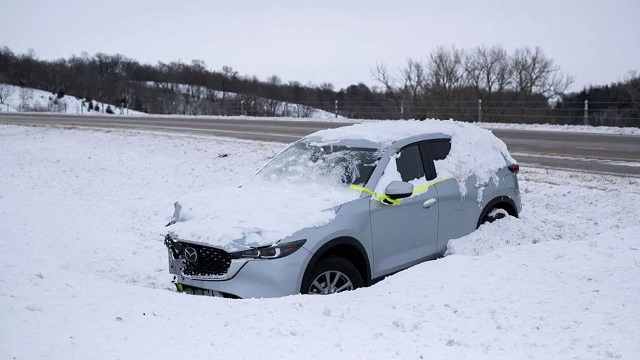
0, 113, 640, 177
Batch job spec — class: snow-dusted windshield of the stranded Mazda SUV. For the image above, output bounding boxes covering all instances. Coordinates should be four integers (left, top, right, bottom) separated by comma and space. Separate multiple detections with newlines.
255, 142, 380, 185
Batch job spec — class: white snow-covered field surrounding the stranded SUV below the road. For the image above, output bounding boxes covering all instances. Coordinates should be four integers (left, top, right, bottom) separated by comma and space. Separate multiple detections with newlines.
0, 126, 640, 360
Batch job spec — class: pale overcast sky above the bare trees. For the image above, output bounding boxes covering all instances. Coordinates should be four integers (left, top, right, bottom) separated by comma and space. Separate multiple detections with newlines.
0, 0, 640, 90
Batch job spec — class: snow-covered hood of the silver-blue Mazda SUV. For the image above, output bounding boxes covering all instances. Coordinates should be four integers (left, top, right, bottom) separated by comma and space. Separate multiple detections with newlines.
163, 181, 360, 252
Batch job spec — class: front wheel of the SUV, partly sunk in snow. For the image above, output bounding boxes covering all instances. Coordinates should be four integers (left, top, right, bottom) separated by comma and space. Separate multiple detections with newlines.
301, 256, 364, 295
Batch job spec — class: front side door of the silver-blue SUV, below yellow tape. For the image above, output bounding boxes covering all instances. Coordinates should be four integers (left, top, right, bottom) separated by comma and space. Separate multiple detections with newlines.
369, 144, 439, 277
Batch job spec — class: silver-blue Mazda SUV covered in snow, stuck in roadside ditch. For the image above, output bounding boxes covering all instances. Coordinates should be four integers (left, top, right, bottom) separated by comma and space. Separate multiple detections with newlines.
164, 120, 521, 298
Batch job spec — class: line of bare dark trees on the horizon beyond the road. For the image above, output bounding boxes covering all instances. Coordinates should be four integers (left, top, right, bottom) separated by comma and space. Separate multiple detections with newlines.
0, 46, 640, 126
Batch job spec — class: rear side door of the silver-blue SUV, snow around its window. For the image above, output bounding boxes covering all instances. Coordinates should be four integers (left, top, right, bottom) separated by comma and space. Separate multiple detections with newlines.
420, 139, 479, 252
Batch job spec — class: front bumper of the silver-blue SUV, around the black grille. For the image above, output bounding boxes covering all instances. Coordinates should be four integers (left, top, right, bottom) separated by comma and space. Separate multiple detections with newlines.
168, 236, 311, 299
